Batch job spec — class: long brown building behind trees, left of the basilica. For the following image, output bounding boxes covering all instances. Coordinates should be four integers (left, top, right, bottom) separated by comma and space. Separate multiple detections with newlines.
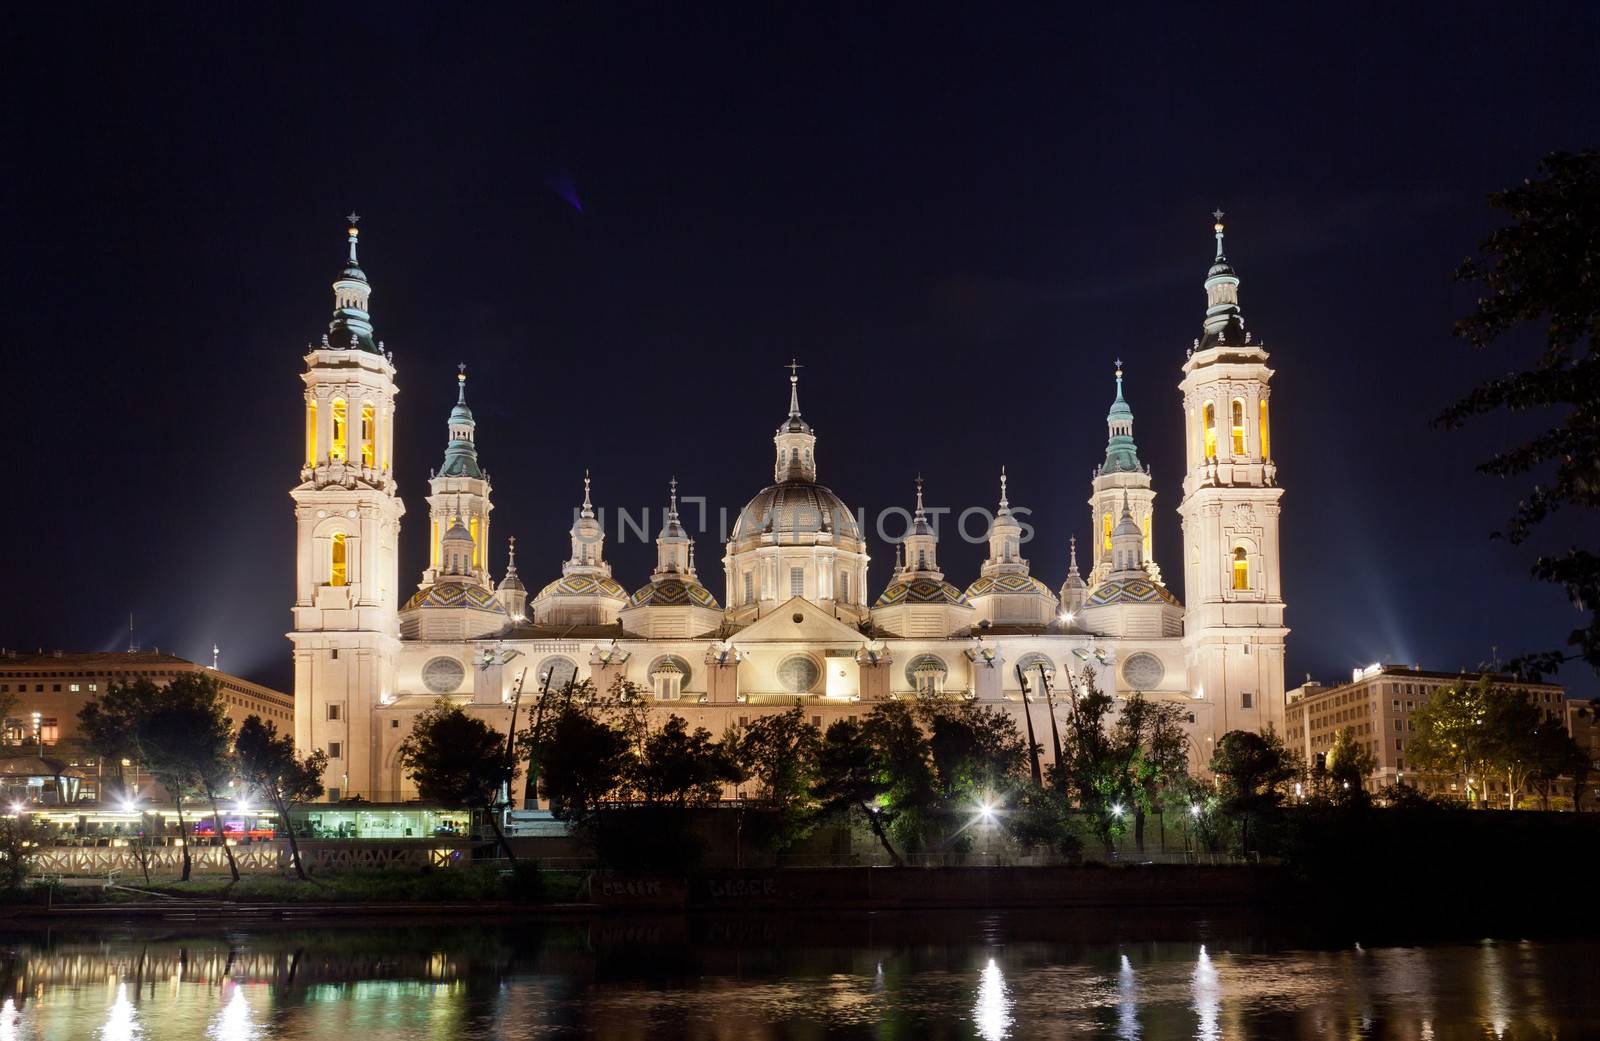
0, 651, 294, 801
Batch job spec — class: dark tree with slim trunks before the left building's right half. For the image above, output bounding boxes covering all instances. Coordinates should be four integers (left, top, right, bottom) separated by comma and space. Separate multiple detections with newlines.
133, 672, 238, 881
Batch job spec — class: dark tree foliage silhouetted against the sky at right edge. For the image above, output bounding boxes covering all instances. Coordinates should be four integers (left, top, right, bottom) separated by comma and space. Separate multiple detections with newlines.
1435, 152, 1600, 676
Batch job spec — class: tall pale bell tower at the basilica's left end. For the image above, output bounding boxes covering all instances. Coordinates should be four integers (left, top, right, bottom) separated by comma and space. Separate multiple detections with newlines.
288, 213, 405, 800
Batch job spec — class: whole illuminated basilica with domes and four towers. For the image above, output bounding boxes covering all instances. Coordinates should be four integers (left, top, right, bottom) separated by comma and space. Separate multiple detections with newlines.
288, 214, 1288, 801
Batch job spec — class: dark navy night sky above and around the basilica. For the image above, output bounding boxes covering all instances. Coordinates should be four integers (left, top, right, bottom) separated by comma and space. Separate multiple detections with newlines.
0, 3, 1600, 696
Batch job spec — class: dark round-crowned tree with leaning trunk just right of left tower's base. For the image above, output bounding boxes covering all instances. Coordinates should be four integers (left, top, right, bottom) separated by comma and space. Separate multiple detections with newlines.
400, 697, 517, 864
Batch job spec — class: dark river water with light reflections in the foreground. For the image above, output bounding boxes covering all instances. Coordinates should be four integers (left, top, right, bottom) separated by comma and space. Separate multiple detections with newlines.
0, 911, 1600, 1041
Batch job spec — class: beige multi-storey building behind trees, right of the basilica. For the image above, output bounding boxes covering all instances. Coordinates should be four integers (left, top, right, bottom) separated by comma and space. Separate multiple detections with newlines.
1283, 664, 1581, 804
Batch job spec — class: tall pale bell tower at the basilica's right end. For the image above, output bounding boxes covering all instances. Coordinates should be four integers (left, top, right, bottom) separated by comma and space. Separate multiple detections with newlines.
1178, 211, 1290, 741
